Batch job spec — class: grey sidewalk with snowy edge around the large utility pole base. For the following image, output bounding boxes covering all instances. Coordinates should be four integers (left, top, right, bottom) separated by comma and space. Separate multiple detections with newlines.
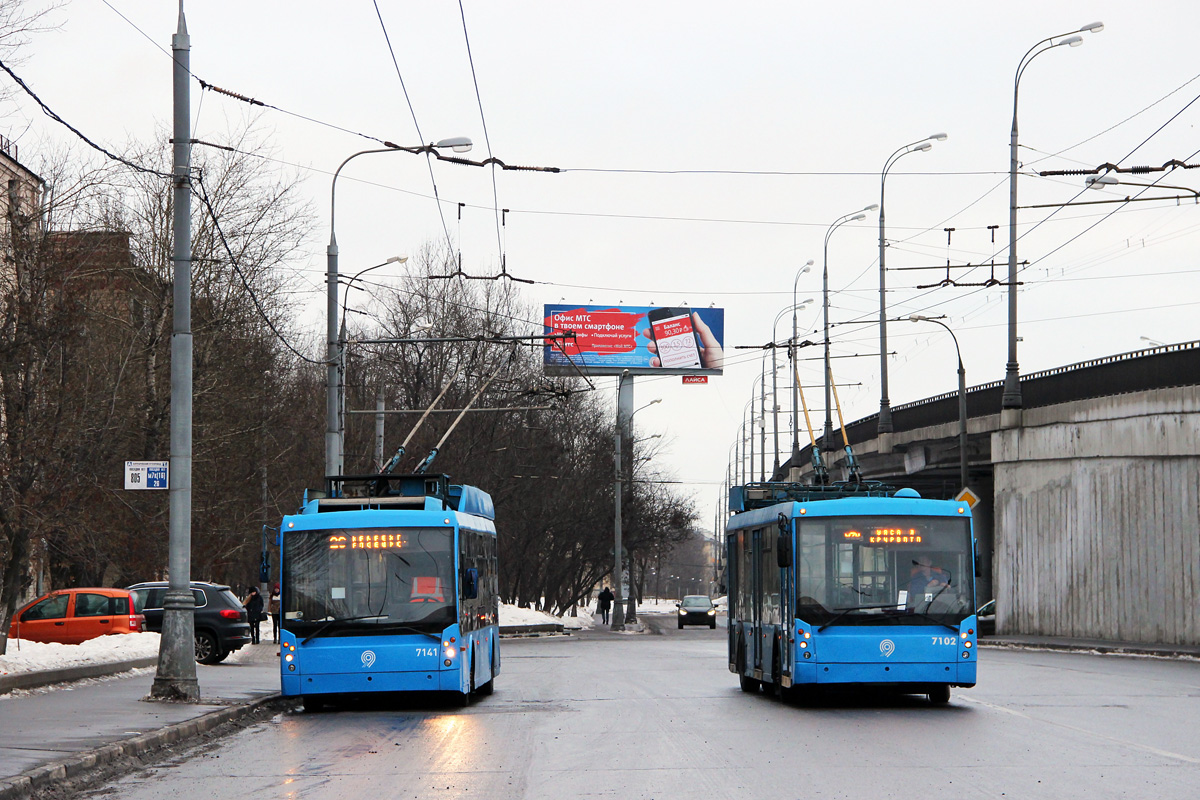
0, 643, 280, 800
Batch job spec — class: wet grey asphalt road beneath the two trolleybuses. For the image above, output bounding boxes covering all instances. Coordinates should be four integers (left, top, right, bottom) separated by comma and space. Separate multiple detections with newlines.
79, 618, 1200, 800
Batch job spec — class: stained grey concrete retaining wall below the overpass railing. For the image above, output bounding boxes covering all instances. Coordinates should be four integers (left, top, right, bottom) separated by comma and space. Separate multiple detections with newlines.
992, 387, 1200, 645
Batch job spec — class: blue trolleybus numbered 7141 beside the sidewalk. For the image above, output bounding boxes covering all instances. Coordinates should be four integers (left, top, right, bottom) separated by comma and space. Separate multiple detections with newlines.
278, 474, 500, 709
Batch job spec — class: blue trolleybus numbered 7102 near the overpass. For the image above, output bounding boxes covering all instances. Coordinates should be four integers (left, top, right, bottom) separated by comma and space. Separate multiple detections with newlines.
726, 482, 977, 703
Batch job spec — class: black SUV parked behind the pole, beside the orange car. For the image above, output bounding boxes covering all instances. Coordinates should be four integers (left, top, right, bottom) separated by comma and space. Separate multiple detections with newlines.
127, 581, 250, 664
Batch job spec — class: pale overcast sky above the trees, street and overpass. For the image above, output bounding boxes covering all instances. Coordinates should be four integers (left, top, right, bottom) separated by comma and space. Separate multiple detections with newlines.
9, 0, 1200, 527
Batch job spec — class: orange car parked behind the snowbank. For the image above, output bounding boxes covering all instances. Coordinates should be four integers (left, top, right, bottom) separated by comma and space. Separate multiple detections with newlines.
8, 589, 145, 644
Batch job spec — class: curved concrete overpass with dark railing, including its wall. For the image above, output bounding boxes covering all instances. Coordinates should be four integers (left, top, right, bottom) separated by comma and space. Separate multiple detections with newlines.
775, 342, 1200, 645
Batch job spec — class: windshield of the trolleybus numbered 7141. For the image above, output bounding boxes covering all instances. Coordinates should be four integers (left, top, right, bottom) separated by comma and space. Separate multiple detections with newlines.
282, 528, 457, 637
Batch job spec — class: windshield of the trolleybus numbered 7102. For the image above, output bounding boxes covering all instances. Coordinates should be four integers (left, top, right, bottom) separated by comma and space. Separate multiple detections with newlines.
796, 516, 974, 626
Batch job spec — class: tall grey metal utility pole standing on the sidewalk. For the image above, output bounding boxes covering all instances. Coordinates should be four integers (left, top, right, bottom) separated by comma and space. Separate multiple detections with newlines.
150, 0, 200, 703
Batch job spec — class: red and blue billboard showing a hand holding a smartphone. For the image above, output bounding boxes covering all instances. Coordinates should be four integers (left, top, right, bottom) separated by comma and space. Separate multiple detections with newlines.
542, 305, 725, 375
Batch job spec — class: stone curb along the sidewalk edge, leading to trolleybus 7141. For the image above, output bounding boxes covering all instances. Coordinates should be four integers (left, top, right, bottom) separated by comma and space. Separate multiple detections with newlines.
0, 694, 280, 800
